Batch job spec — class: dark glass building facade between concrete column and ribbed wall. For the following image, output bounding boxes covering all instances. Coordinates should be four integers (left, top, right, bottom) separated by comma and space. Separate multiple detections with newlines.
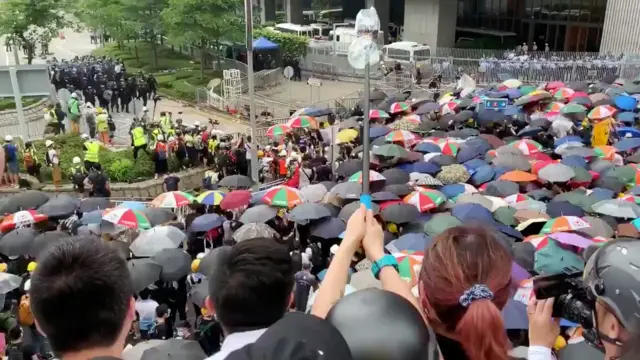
456, 0, 608, 52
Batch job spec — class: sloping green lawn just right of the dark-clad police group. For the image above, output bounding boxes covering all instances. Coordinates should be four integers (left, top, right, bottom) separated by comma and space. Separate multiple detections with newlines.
93, 42, 222, 101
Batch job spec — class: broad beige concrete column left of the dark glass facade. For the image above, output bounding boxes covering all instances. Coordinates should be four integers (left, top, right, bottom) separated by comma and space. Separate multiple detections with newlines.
403, 0, 458, 49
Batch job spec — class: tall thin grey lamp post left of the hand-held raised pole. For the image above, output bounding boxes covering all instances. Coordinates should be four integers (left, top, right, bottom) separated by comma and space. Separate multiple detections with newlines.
244, 0, 258, 183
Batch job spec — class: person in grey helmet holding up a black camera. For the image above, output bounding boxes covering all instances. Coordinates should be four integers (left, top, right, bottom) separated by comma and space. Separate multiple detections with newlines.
527, 239, 640, 360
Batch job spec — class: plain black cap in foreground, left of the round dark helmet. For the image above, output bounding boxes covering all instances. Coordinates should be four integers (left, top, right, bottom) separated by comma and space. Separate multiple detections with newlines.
226, 313, 352, 360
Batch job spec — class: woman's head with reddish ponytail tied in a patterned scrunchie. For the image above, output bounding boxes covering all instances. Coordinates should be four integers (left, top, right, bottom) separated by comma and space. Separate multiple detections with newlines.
419, 226, 512, 360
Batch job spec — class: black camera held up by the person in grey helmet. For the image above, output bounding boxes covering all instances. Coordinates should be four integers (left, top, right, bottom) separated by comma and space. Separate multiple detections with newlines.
533, 267, 596, 330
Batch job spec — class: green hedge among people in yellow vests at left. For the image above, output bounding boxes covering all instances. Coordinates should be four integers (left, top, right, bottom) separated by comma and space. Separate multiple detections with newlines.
19, 134, 180, 183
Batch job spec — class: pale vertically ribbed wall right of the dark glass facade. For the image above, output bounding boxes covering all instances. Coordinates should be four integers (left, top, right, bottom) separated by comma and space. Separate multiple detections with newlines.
600, 0, 640, 54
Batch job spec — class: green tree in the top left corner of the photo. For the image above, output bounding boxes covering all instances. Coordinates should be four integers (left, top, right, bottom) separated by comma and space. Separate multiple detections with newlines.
0, 0, 72, 64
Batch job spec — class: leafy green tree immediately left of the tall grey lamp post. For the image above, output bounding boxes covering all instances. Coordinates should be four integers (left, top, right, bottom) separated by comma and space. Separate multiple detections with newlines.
162, 0, 242, 78
